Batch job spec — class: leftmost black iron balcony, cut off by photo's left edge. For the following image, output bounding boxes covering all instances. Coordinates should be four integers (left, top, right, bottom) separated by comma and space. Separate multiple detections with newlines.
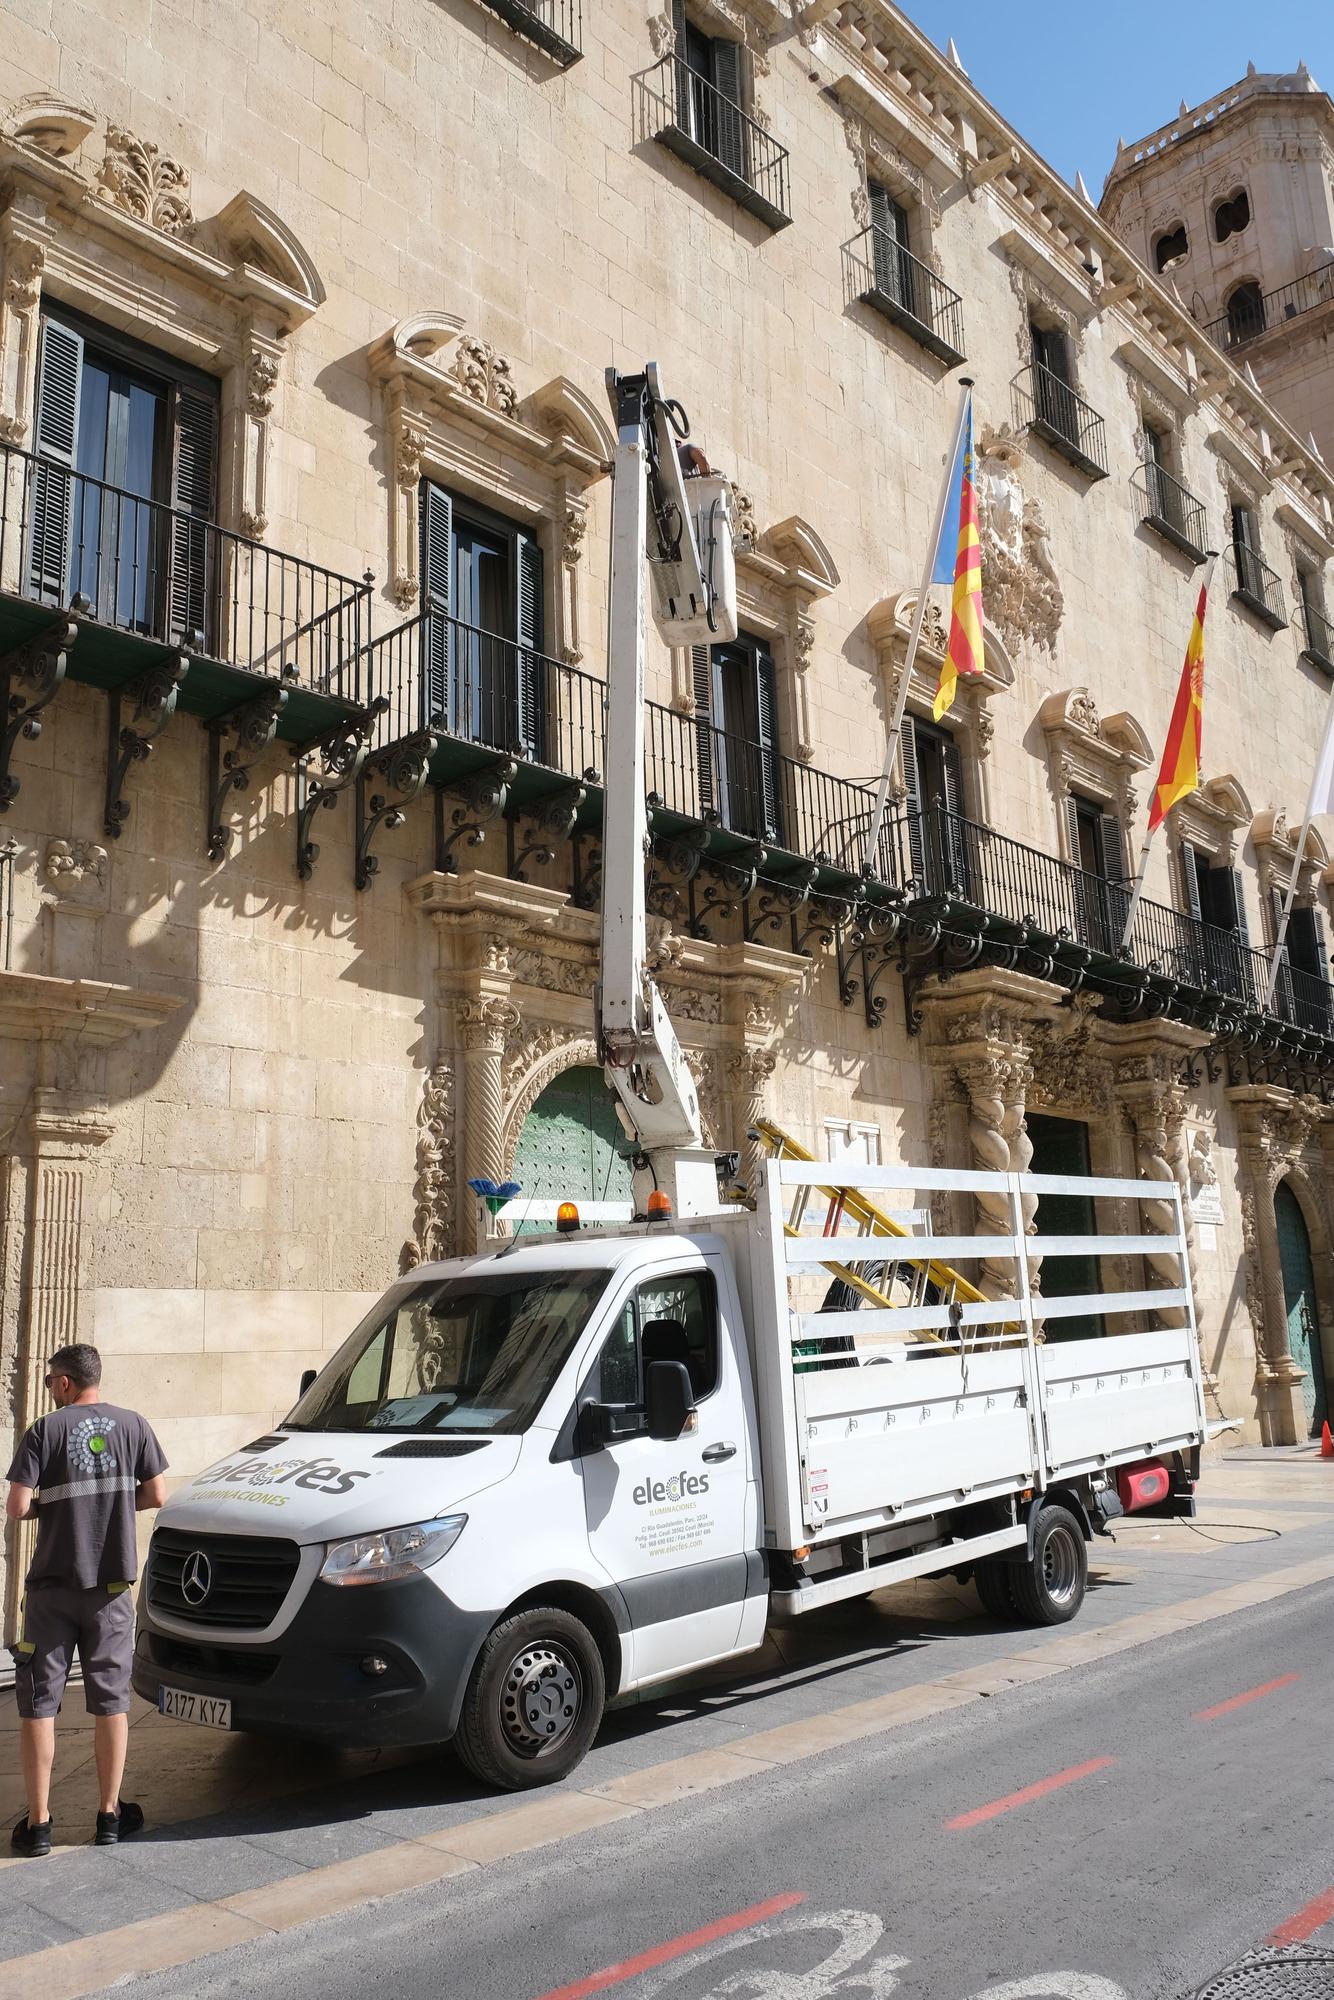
0, 446, 370, 742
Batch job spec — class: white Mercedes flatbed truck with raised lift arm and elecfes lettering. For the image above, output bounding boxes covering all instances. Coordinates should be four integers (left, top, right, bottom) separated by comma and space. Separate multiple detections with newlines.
134, 368, 1206, 1788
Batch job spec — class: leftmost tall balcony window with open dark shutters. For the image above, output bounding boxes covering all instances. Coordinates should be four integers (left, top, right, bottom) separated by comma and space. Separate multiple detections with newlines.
28, 312, 218, 650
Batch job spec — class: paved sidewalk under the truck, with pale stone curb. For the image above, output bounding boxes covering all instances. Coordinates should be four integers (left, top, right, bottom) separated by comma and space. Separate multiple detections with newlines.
0, 1448, 1334, 2000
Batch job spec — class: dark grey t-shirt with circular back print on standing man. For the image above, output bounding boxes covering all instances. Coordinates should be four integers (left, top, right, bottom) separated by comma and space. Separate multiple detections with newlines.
10, 1402, 166, 1590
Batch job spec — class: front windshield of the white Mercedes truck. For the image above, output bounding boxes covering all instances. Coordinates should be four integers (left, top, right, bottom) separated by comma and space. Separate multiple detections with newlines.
284, 1270, 608, 1434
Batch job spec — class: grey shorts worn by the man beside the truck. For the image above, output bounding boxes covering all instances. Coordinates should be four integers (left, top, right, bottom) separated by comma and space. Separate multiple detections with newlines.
14, 1584, 134, 1722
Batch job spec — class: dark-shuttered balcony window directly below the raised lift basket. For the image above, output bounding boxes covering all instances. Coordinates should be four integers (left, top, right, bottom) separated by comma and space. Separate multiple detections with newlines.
690, 632, 784, 844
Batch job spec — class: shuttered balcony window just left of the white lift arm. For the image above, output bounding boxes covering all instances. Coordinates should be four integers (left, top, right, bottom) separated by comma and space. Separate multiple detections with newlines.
420, 480, 552, 760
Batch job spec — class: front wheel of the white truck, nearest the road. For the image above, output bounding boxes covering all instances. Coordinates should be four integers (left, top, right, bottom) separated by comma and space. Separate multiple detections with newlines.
454, 1606, 606, 1792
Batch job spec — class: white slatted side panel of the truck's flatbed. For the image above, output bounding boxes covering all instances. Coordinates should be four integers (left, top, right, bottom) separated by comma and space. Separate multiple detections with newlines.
752, 1156, 1206, 1548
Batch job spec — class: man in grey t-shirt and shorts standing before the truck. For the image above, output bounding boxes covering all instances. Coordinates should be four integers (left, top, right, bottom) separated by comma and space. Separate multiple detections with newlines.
4, 1344, 166, 1854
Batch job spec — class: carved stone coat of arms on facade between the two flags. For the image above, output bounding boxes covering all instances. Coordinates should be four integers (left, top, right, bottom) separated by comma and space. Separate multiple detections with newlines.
978, 426, 1066, 652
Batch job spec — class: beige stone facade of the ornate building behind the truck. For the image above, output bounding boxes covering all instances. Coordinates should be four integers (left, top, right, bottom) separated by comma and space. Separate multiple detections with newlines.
0, 0, 1334, 1624
